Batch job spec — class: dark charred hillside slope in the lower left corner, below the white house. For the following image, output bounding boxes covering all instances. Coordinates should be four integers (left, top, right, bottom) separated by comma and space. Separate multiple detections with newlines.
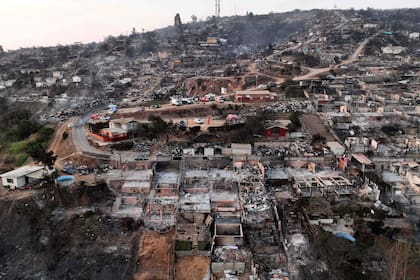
0, 185, 138, 279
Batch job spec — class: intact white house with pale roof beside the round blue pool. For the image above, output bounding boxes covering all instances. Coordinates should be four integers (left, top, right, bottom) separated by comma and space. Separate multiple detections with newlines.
0, 165, 45, 190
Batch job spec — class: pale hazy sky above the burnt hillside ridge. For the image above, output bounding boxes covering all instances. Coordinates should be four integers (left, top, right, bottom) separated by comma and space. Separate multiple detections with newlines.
0, 0, 420, 49
